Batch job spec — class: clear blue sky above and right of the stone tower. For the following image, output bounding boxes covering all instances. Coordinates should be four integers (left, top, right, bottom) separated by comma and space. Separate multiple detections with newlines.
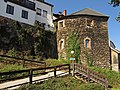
46, 0, 120, 50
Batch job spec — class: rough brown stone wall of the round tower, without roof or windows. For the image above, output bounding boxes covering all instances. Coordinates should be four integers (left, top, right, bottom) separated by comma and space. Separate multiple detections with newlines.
57, 16, 110, 67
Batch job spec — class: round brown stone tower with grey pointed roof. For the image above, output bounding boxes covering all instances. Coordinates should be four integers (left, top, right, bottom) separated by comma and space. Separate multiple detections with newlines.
54, 8, 110, 68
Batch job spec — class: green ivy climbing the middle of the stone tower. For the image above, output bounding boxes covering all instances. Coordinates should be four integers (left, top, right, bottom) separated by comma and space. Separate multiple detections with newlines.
66, 31, 80, 61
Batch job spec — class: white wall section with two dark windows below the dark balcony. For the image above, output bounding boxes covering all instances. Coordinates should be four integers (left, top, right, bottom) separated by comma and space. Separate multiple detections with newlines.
0, 0, 36, 25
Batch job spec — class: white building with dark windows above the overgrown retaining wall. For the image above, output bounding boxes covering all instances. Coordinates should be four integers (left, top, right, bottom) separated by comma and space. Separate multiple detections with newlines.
0, 0, 53, 30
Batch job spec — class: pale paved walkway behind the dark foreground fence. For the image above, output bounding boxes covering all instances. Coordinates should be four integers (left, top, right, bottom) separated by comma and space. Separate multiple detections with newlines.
0, 71, 69, 90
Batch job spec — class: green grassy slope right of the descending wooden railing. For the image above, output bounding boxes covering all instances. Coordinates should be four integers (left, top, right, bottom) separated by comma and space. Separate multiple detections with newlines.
90, 67, 120, 88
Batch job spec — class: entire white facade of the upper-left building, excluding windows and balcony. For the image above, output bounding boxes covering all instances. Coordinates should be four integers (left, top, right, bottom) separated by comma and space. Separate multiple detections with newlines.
0, 0, 53, 30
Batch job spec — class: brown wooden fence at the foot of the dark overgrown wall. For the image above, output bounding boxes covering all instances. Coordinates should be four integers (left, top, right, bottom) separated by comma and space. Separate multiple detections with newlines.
0, 55, 46, 67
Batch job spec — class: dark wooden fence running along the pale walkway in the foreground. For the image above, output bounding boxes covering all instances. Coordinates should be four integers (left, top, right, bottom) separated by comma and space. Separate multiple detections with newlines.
0, 64, 70, 88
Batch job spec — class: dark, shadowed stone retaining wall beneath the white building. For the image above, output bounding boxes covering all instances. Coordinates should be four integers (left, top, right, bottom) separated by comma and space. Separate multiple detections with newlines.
0, 16, 57, 58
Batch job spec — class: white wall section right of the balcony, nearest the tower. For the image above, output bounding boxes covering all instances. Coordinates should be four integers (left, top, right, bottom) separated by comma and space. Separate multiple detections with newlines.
35, 1, 53, 30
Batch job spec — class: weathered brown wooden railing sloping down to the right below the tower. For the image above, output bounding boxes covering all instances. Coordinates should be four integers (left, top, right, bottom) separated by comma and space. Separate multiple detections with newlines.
73, 64, 109, 88
